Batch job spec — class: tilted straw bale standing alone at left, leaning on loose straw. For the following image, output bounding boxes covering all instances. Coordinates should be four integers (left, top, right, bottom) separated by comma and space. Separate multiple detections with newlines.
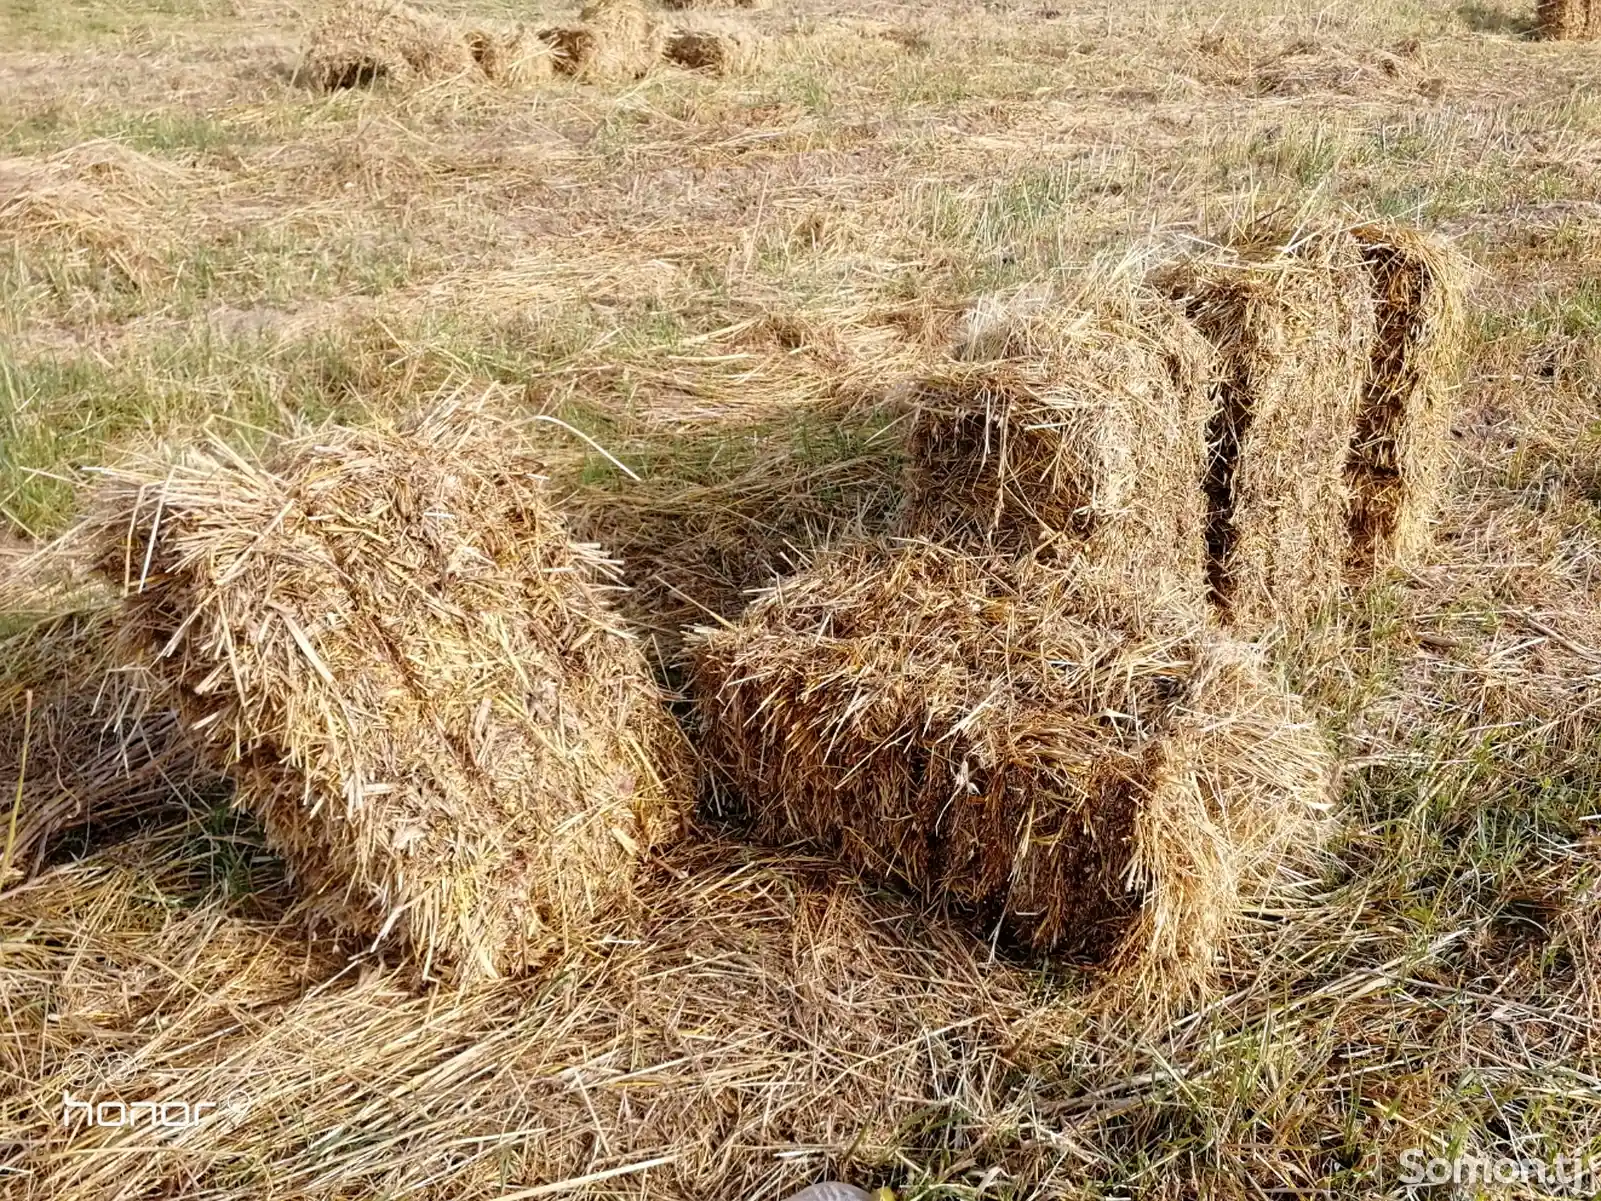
91, 404, 688, 975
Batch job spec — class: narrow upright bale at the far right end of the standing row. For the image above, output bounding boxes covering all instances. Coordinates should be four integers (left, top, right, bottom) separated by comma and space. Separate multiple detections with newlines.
1346, 223, 1467, 572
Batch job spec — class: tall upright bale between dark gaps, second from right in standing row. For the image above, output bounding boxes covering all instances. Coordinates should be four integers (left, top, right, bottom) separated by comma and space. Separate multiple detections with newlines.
1172, 234, 1375, 628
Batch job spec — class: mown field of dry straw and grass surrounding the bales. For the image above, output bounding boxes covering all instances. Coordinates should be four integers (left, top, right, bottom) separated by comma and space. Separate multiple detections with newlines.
0, 0, 1601, 1201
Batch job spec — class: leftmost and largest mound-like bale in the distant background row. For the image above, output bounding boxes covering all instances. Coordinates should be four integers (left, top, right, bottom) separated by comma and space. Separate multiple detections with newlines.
303, 0, 474, 91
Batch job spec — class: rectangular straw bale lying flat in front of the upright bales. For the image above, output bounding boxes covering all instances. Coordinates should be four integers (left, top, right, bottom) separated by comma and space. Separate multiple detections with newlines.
693, 544, 1330, 994
